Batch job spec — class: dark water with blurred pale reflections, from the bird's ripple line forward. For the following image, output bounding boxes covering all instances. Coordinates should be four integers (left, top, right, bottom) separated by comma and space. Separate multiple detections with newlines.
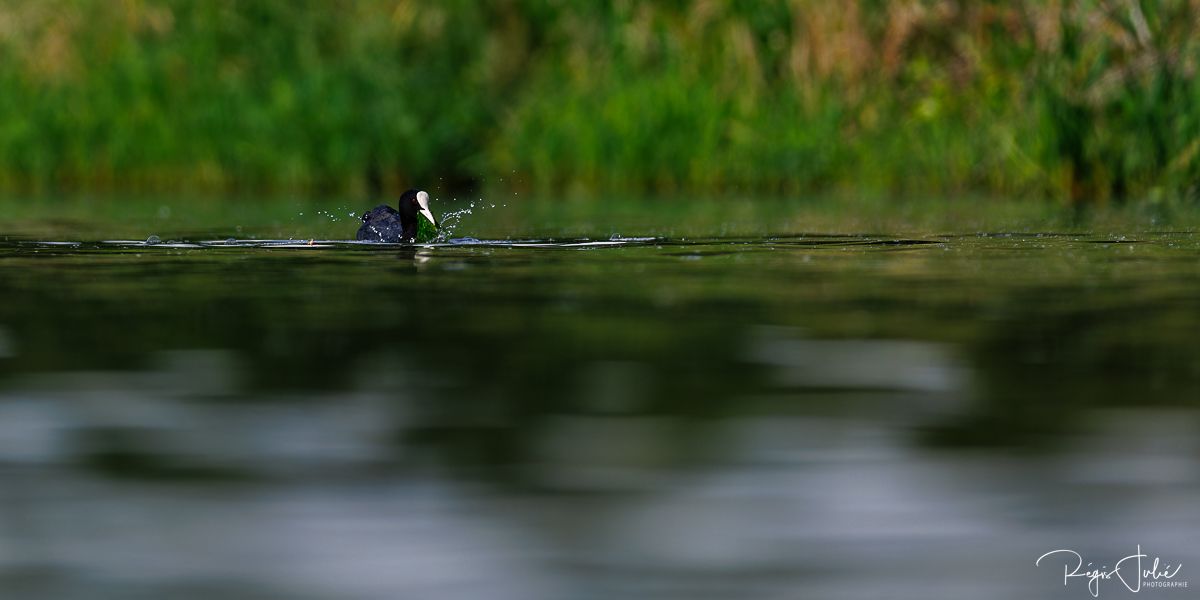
0, 234, 1200, 599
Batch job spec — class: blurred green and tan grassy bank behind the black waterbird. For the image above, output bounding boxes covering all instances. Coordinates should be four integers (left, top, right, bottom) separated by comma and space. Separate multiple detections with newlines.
0, 0, 1200, 204
